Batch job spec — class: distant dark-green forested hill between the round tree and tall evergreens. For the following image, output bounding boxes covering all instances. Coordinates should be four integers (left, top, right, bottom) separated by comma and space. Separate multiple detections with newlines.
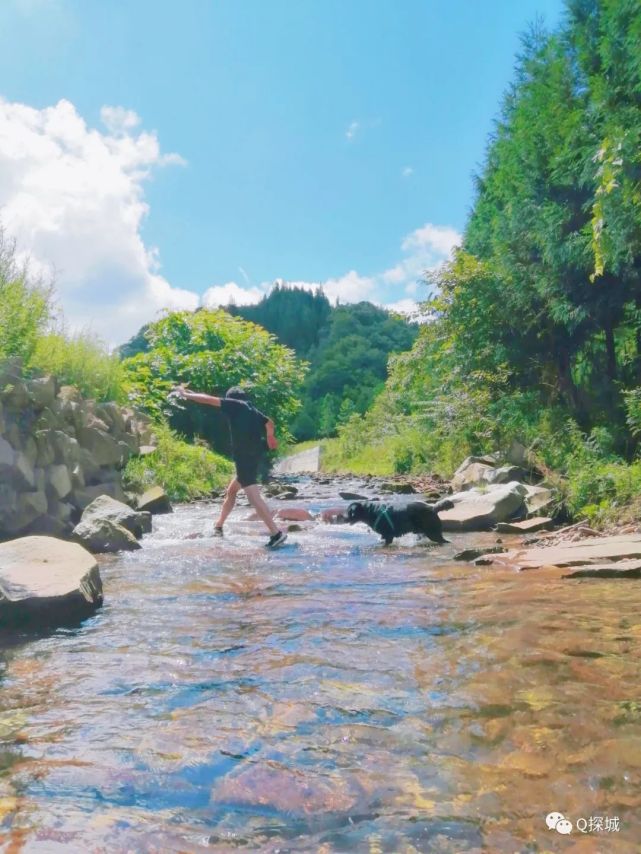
227, 285, 418, 440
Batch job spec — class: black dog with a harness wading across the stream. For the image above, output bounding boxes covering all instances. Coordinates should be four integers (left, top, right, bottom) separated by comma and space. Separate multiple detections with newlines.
343, 498, 454, 546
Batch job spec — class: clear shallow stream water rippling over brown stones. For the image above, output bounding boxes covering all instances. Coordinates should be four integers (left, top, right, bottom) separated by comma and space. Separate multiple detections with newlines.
0, 488, 641, 854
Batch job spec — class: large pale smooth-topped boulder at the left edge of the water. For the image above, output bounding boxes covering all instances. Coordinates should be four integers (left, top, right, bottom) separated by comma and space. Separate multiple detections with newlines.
0, 536, 102, 625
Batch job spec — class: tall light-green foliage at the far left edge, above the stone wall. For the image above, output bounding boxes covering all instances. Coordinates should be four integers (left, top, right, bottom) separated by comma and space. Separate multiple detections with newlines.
0, 230, 52, 364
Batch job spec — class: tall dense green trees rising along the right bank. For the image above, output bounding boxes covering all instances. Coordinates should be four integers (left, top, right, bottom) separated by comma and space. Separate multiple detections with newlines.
332, 0, 641, 516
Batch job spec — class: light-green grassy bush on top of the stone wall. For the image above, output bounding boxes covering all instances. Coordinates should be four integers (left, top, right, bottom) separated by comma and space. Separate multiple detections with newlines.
30, 332, 123, 401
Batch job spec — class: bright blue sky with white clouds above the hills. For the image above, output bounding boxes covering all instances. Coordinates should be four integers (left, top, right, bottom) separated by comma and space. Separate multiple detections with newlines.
0, 0, 562, 340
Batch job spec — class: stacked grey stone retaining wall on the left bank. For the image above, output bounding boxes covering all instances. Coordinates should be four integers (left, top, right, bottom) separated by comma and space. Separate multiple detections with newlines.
0, 359, 155, 541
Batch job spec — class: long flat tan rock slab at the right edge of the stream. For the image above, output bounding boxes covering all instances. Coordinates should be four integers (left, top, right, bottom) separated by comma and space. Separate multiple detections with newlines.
494, 534, 641, 569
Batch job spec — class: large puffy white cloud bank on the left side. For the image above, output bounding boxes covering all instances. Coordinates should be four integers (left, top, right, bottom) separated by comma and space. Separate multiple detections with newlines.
0, 99, 199, 343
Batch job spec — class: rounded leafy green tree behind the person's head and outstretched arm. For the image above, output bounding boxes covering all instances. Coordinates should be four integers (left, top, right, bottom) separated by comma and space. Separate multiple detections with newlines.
122, 310, 306, 451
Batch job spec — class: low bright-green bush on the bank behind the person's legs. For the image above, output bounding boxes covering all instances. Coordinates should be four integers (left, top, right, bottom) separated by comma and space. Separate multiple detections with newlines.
124, 422, 233, 501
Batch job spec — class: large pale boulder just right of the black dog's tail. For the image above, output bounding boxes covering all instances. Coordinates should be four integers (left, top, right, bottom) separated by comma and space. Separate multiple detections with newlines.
439, 481, 527, 531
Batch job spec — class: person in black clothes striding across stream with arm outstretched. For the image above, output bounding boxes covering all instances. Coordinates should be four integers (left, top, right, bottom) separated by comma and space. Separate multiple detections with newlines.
172, 385, 287, 549
